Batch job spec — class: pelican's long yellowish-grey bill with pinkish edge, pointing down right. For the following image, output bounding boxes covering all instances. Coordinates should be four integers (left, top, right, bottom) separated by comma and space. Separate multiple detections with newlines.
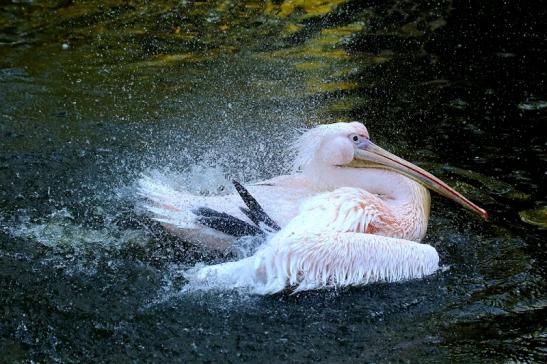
349, 139, 488, 220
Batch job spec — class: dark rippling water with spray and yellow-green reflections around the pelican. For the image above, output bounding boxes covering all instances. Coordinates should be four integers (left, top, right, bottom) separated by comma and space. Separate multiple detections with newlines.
0, 0, 547, 362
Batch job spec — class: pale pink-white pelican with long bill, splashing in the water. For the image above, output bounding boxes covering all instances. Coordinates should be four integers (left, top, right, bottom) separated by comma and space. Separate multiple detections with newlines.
139, 122, 488, 294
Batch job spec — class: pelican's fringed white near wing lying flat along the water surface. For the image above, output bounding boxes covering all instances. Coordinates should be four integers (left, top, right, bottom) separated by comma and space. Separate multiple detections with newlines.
188, 232, 439, 294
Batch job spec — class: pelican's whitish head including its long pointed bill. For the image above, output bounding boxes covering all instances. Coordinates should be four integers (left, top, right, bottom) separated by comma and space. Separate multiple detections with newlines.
294, 121, 488, 219
